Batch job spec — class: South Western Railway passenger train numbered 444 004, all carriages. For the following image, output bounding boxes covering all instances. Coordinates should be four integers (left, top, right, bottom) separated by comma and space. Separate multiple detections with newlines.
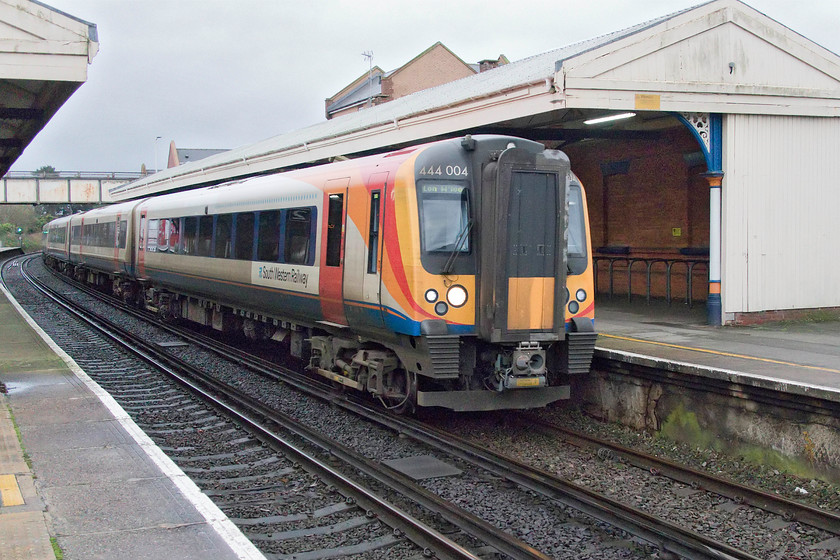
43, 135, 597, 413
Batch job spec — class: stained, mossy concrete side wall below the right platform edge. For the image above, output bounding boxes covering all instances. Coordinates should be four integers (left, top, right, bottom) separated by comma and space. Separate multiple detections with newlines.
571, 361, 840, 482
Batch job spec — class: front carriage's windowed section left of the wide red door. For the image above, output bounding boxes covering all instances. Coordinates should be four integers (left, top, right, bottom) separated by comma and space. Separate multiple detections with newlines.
135, 176, 322, 330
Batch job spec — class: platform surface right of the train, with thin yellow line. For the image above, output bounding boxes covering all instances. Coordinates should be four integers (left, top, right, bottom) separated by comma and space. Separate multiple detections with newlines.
595, 300, 840, 402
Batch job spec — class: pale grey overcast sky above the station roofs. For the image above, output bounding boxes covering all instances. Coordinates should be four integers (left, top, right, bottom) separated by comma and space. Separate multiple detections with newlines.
12, 0, 840, 171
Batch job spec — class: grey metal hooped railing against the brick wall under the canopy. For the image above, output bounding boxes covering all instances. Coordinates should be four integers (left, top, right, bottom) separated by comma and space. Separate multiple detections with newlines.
592, 255, 709, 309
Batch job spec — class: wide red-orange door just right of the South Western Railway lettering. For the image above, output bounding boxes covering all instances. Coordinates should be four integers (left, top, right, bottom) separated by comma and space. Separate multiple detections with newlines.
318, 177, 350, 325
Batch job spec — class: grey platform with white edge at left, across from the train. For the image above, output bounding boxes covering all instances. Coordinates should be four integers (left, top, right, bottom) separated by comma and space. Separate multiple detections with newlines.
0, 290, 264, 560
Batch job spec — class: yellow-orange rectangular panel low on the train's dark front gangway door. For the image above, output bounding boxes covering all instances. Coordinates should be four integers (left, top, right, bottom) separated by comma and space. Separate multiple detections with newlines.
507, 278, 554, 331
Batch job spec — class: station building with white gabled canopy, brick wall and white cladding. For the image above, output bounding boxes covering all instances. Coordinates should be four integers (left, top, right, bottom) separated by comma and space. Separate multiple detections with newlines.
115, 0, 840, 324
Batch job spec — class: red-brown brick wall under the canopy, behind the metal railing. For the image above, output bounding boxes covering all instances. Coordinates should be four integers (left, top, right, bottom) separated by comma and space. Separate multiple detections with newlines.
563, 129, 709, 301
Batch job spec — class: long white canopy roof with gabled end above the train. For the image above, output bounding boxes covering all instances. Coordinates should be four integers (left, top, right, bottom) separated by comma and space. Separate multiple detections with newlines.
110, 0, 840, 200
